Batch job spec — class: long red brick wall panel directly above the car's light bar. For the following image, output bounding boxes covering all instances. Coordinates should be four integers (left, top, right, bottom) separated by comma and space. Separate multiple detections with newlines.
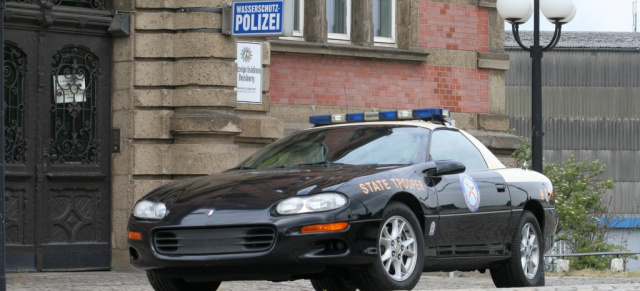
270, 54, 489, 113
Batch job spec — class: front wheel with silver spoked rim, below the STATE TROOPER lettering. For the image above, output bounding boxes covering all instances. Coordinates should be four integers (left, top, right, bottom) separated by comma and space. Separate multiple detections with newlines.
352, 202, 424, 291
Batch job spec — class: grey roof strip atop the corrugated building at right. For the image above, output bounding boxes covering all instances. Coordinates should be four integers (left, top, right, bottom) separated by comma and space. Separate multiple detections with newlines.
505, 30, 640, 50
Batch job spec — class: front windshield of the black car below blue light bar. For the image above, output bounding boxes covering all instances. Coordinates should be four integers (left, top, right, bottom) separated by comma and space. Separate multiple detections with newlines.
238, 125, 429, 169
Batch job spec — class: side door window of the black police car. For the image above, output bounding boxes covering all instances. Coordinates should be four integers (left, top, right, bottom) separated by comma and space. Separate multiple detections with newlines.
429, 130, 487, 171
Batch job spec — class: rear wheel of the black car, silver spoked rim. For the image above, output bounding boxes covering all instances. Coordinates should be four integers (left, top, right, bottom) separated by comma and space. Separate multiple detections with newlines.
491, 210, 544, 288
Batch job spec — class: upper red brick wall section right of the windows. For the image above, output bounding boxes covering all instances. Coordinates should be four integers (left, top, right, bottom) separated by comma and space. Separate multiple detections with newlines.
419, 2, 489, 52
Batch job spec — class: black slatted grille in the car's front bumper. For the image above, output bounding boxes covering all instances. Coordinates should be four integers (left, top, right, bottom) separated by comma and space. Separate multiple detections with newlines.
153, 227, 276, 255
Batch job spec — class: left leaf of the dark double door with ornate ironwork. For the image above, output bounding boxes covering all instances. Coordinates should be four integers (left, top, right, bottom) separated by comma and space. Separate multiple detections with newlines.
4, 31, 38, 270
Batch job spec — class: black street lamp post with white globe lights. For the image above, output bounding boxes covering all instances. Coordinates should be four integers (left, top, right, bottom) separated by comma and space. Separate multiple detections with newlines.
496, 0, 576, 173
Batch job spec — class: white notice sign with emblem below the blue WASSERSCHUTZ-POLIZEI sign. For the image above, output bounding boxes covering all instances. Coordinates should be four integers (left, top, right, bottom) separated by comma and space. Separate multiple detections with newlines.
235, 42, 262, 103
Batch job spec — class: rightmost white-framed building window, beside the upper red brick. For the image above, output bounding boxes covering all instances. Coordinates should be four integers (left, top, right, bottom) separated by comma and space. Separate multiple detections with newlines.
373, 0, 396, 43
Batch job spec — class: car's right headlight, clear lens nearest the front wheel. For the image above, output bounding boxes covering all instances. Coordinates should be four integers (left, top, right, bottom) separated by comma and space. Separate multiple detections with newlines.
276, 193, 347, 215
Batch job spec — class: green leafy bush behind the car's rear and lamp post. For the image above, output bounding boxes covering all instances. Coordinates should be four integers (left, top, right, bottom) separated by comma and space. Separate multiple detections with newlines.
513, 137, 624, 270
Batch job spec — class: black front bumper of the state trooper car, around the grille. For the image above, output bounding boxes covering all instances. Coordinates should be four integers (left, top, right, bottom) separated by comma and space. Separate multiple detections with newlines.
129, 214, 380, 281
